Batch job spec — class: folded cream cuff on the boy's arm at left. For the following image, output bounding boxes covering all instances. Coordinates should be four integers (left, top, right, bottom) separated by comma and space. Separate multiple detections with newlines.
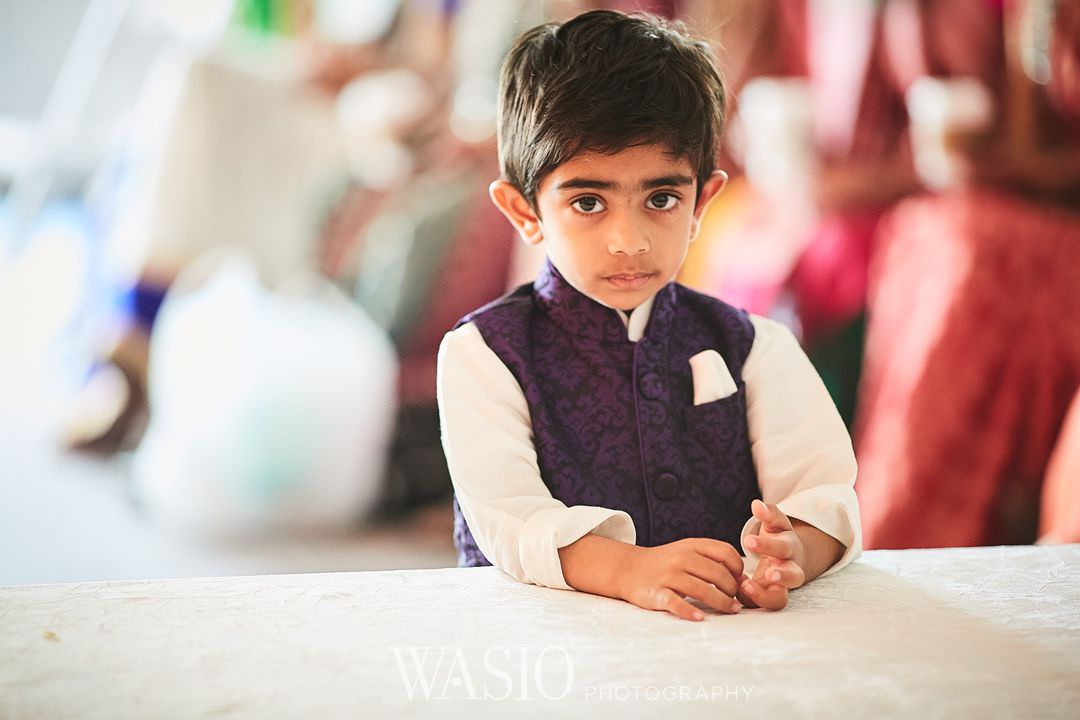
517, 505, 637, 590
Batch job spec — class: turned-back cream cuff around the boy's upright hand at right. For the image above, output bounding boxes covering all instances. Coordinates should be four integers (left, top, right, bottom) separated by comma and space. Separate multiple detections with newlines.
740, 484, 863, 578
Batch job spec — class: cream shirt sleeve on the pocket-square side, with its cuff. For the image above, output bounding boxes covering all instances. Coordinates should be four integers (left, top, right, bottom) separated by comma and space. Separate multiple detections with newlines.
741, 315, 862, 574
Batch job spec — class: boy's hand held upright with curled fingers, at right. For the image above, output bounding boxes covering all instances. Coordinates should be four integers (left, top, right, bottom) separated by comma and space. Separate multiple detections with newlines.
738, 500, 806, 610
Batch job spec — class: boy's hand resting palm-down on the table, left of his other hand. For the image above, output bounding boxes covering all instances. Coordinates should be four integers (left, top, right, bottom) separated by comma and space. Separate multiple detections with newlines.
620, 538, 745, 621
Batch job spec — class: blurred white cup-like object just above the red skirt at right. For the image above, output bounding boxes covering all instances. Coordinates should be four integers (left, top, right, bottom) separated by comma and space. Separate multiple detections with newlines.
906, 78, 994, 189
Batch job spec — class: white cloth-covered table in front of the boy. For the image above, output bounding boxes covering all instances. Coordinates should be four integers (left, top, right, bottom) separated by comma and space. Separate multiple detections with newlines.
0, 545, 1080, 720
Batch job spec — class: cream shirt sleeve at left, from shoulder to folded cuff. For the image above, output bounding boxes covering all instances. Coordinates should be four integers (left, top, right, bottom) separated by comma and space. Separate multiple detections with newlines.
437, 323, 636, 589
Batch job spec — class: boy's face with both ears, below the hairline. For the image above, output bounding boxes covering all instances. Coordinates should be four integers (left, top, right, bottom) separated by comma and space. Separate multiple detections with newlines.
490, 145, 727, 310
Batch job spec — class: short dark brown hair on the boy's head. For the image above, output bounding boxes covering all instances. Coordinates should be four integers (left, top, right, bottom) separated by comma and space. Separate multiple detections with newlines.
499, 10, 726, 206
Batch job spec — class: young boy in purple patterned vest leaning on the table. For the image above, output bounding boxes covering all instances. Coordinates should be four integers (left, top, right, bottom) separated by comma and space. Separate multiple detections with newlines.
438, 11, 861, 620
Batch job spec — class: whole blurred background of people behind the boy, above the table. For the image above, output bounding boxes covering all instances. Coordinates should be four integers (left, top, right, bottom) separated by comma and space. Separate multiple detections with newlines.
0, 0, 1080, 584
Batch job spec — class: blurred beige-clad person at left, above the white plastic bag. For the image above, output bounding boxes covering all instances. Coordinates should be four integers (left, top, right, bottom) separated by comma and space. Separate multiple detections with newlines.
64, 0, 377, 454
